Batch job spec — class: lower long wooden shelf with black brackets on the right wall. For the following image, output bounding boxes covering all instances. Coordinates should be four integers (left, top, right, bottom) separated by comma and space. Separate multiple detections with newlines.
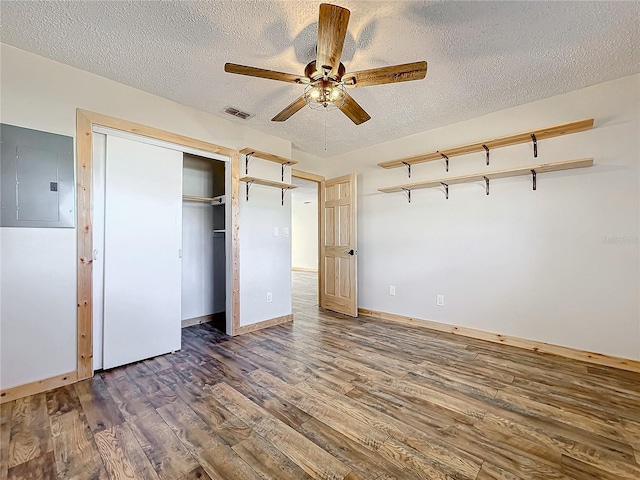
378, 158, 593, 202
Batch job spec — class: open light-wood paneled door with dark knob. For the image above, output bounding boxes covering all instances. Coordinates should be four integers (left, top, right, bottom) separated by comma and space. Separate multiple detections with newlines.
320, 173, 358, 317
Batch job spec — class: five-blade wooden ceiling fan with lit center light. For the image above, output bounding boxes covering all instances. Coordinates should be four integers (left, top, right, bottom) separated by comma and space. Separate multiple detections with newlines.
224, 3, 427, 125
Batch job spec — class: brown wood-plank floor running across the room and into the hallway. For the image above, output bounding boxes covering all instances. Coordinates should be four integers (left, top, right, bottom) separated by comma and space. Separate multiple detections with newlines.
0, 273, 640, 480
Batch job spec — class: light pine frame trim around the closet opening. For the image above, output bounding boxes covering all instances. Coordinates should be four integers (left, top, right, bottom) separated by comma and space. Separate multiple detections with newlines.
75, 108, 240, 383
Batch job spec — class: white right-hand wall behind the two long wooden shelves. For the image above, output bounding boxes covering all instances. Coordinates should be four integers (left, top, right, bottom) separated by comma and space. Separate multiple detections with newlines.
322, 75, 640, 360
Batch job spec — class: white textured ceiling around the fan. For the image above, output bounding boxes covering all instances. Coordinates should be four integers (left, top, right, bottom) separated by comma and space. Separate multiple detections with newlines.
0, 0, 640, 157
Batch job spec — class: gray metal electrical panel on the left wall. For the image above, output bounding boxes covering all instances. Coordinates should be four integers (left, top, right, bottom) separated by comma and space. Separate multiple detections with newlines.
0, 123, 75, 228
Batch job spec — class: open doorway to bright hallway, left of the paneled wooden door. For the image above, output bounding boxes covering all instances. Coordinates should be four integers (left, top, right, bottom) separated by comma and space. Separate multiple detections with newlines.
291, 169, 324, 312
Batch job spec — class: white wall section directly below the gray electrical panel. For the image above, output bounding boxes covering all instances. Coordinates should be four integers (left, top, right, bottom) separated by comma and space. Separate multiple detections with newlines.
0, 228, 77, 388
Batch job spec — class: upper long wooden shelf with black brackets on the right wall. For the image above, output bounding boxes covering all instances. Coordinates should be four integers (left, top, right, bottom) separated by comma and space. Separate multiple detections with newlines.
378, 118, 593, 172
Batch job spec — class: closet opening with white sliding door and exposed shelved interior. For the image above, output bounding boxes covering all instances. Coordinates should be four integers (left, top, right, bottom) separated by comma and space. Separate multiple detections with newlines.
92, 127, 231, 369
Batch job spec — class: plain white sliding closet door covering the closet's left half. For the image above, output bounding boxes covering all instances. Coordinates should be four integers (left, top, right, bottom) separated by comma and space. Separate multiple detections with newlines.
103, 135, 182, 369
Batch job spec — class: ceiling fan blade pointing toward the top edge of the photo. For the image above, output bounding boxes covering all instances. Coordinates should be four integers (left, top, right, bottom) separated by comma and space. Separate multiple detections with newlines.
316, 3, 350, 76
